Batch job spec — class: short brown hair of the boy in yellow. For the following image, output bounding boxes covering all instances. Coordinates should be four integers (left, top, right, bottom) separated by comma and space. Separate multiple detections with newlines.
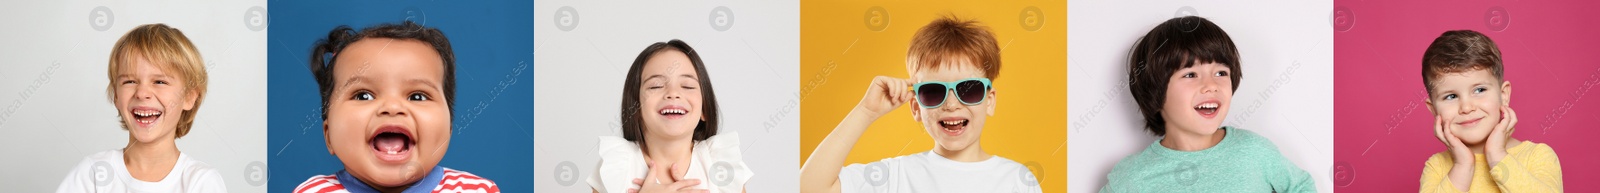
1422, 30, 1506, 96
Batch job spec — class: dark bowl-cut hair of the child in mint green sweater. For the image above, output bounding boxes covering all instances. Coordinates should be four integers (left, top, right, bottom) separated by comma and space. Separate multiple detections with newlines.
1128, 16, 1245, 136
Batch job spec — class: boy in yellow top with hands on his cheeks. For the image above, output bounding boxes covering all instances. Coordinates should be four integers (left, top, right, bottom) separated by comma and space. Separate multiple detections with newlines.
1421, 30, 1562, 193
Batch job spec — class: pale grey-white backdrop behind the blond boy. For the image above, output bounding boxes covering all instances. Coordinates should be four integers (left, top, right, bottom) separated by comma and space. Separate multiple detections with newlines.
0, 0, 267, 193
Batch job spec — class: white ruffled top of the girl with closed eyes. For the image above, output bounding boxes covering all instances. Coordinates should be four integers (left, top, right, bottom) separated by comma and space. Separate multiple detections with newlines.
587, 131, 755, 193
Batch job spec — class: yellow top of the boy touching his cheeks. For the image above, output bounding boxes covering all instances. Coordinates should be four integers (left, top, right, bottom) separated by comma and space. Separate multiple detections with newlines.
1421, 140, 1563, 193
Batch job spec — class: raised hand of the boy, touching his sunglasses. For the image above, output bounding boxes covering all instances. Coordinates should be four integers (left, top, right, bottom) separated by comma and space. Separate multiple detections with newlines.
854, 77, 917, 120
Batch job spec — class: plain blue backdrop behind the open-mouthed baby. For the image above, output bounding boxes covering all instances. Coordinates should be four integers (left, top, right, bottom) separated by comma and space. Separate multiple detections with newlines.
267, 0, 534, 193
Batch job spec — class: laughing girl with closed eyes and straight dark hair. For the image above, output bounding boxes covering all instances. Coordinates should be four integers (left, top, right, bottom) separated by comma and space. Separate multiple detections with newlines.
589, 40, 754, 193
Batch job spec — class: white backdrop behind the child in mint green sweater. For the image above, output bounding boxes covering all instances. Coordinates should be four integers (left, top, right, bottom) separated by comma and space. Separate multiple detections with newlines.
1067, 0, 1333, 193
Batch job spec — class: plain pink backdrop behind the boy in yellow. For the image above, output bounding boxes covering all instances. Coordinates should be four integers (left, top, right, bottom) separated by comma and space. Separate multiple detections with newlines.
1330, 0, 1600, 193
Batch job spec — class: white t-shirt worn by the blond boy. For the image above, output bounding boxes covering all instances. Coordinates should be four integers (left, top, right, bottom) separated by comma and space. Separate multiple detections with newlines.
56, 148, 227, 193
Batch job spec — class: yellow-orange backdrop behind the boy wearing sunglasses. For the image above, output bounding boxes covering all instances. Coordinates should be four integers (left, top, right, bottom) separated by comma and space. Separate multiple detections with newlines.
797, 0, 1067, 193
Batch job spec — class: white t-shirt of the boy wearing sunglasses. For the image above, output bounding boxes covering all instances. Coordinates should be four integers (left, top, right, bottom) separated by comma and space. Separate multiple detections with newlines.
838, 152, 1042, 193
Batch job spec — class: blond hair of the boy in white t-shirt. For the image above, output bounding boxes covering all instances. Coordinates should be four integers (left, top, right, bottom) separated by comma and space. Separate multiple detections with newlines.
106, 24, 206, 137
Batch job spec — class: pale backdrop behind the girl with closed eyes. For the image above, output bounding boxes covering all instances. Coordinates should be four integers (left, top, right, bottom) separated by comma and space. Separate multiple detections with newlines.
533, 0, 800, 193
